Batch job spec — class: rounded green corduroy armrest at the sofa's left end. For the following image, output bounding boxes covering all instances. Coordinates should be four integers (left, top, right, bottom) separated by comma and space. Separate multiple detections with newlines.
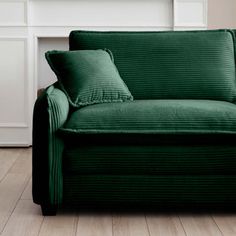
33, 85, 69, 205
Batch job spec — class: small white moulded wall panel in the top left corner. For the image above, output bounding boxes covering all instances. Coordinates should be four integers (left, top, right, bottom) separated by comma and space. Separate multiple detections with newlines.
0, 0, 28, 26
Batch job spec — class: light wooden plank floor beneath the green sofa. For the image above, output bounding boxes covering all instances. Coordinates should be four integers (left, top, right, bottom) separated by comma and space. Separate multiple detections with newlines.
0, 148, 236, 236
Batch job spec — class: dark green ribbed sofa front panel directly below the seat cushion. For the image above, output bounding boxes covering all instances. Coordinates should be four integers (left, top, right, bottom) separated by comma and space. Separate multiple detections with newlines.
63, 144, 236, 175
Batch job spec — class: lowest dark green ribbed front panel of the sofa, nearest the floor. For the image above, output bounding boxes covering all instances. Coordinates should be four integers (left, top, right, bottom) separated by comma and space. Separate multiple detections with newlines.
64, 175, 236, 207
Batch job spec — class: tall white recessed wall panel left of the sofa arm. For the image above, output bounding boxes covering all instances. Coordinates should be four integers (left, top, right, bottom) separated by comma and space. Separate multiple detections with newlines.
0, 38, 28, 127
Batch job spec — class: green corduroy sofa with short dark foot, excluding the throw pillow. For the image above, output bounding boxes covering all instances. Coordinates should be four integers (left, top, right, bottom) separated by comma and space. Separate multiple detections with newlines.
33, 30, 236, 215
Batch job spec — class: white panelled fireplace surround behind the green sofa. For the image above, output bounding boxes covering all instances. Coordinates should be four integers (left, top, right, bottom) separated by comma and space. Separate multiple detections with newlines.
0, 0, 207, 146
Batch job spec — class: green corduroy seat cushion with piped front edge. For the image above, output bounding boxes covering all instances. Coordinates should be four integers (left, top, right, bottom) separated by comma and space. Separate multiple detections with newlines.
60, 100, 236, 135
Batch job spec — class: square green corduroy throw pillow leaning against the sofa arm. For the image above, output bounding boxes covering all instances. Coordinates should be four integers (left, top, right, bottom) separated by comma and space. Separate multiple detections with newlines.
45, 49, 133, 107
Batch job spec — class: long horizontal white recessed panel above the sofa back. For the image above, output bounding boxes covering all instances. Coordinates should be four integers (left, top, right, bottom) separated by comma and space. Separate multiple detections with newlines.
29, 0, 172, 27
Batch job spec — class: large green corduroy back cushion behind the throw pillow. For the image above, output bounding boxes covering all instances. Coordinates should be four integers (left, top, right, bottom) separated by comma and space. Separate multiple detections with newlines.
70, 30, 236, 102
